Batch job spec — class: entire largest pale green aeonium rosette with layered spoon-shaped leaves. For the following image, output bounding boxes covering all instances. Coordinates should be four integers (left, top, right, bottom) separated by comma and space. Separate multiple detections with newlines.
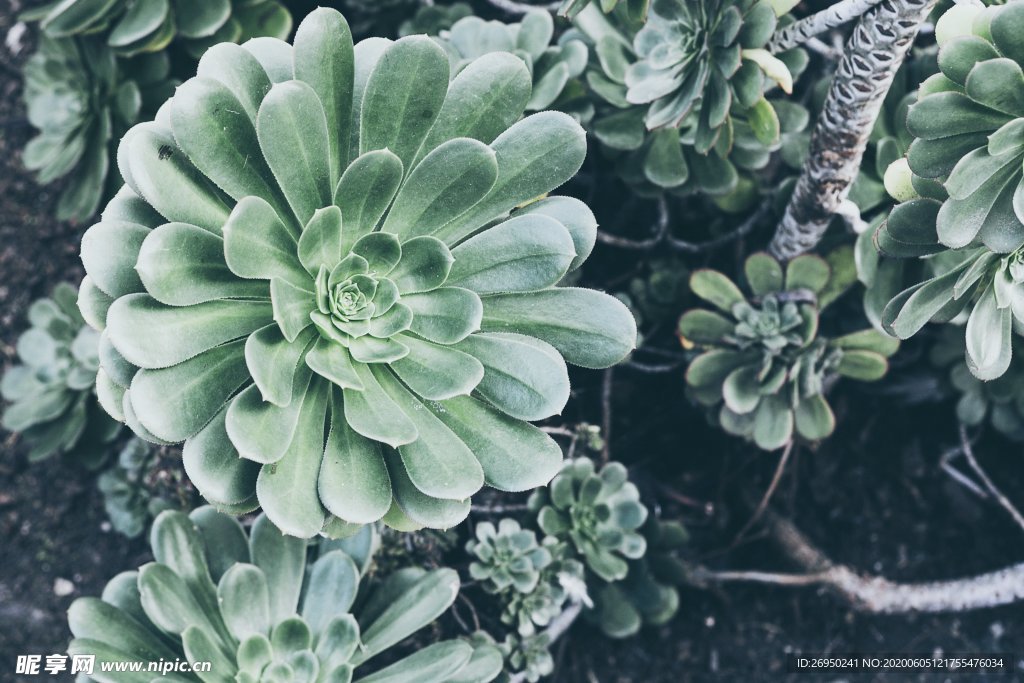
80, 9, 636, 537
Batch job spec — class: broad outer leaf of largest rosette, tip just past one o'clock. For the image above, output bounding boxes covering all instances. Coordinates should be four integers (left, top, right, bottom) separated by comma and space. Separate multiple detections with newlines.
420, 52, 532, 157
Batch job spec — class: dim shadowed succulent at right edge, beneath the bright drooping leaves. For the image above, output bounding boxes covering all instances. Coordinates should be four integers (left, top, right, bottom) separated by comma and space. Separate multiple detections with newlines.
929, 325, 1024, 441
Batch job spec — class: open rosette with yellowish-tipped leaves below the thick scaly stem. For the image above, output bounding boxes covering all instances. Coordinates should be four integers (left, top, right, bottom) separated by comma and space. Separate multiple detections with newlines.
679, 250, 899, 451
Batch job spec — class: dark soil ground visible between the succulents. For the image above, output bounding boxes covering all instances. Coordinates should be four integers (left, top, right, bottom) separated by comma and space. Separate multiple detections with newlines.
0, 0, 1024, 683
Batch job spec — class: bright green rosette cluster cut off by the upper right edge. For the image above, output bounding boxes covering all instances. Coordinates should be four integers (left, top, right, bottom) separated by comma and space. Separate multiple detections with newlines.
874, 3, 1024, 380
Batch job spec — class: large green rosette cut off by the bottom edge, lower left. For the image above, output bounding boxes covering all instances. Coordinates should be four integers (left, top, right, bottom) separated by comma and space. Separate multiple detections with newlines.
68, 507, 502, 683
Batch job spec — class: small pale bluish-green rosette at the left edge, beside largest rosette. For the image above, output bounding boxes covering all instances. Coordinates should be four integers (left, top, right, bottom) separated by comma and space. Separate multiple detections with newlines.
0, 283, 121, 469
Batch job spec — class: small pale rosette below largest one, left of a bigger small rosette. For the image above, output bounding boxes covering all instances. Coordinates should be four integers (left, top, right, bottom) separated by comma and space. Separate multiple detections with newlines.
466, 518, 552, 593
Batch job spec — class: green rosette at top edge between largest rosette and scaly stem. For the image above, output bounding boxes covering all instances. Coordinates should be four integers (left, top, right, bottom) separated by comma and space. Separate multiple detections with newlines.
575, 1, 809, 199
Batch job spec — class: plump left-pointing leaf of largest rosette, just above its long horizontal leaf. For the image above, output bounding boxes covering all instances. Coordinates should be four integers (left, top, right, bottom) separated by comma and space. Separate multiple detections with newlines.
135, 223, 270, 306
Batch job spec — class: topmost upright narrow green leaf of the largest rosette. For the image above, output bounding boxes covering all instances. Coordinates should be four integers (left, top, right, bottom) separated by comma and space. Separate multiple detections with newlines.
294, 7, 355, 183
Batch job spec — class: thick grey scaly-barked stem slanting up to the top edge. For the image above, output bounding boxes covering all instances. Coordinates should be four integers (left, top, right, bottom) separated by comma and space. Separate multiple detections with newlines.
769, 0, 935, 260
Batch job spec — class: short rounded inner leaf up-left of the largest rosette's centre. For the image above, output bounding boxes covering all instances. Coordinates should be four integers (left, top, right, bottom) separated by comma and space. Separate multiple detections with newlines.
224, 197, 312, 287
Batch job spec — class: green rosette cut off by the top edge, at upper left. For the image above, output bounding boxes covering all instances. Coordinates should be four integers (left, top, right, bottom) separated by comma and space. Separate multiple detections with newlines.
26, 0, 292, 58
